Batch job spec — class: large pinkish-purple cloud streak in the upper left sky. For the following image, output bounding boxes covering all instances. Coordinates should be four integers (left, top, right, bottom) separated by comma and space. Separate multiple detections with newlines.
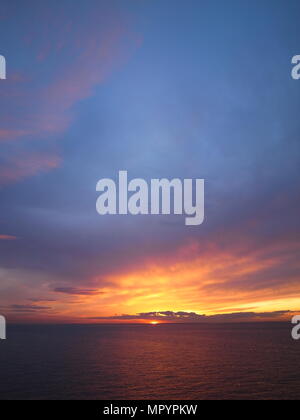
0, 7, 141, 142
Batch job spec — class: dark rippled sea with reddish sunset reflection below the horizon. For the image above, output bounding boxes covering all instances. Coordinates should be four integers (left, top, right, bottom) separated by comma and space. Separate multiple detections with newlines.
0, 323, 300, 400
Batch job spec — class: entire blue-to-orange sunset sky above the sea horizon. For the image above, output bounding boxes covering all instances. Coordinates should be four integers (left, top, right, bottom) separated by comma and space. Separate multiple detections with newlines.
0, 0, 300, 322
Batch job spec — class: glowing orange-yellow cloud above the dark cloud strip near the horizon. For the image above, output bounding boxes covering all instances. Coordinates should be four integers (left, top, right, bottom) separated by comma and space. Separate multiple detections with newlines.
67, 236, 300, 317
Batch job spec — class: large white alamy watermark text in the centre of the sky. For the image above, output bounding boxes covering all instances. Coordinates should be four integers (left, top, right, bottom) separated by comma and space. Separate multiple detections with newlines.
96, 171, 204, 226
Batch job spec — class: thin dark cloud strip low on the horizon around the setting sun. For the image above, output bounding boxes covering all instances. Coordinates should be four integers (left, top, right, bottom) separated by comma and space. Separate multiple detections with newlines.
89, 310, 291, 323
